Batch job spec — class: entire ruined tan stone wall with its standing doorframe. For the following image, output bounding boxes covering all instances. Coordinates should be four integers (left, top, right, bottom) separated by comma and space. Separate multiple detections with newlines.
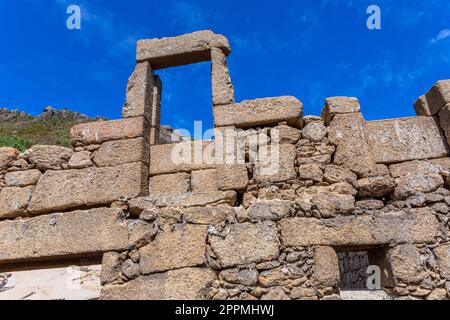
0, 31, 450, 300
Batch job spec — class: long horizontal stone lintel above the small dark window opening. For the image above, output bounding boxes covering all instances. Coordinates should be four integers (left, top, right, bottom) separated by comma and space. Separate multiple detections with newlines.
280, 209, 439, 247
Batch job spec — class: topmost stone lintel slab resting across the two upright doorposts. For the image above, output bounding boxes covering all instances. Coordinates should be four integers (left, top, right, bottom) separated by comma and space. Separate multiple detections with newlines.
136, 30, 231, 70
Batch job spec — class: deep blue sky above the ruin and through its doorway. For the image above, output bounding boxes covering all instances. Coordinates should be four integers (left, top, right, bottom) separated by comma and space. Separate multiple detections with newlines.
0, 0, 450, 134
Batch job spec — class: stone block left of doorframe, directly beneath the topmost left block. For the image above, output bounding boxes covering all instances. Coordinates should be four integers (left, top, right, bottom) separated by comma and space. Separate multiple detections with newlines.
93, 138, 149, 167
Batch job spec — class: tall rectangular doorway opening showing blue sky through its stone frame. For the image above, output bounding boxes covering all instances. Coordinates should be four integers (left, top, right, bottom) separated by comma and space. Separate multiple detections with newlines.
157, 61, 213, 144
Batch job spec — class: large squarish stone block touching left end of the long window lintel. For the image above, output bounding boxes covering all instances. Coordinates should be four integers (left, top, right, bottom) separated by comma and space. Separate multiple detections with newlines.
209, 223, 279, 268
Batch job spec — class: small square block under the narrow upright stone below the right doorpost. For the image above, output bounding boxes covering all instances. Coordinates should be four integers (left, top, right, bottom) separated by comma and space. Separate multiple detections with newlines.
216, 164, 248, 190
